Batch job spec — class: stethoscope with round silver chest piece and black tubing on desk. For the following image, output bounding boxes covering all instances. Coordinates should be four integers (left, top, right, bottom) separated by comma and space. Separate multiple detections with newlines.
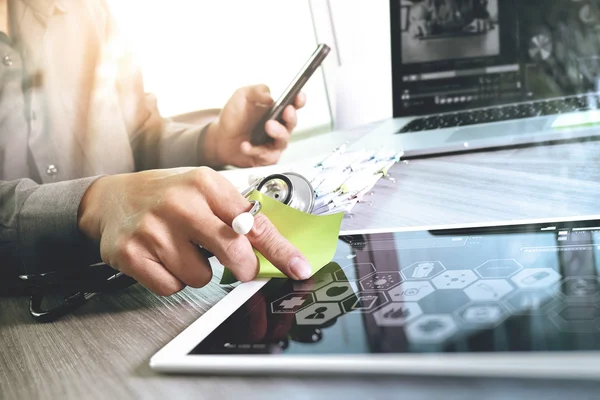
19, 172, 315, 322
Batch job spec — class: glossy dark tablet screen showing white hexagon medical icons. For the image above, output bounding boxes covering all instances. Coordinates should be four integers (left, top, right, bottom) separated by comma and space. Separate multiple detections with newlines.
191, 221, 600, 356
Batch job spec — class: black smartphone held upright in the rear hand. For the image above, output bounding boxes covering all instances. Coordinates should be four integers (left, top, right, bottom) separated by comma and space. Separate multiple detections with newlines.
250, 44, 331, 146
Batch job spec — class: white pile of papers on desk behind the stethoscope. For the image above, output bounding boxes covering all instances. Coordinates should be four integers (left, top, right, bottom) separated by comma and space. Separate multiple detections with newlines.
223, 145, 403, 215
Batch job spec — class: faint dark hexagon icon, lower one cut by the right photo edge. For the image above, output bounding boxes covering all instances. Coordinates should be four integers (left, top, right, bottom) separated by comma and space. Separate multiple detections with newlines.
548, 303, 600, 333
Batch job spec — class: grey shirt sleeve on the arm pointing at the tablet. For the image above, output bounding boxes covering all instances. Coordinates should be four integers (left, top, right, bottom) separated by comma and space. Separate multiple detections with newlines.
0, 177, 101, 289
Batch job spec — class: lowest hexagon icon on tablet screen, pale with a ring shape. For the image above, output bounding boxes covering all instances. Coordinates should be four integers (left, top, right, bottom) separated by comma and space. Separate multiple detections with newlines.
405, 314, 458, 344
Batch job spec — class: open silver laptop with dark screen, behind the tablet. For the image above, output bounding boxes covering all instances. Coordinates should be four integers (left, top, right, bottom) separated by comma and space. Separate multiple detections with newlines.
352, 0, 600, 158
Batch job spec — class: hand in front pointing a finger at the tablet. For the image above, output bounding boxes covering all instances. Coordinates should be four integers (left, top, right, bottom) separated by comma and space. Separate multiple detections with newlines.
78, 168, 312, 296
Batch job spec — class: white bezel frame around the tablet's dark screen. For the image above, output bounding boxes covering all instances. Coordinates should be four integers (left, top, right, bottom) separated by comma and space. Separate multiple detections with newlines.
150, 215, 600, 379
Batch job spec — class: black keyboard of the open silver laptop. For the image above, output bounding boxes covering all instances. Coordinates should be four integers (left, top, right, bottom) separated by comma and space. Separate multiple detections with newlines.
398, 94, 599, 133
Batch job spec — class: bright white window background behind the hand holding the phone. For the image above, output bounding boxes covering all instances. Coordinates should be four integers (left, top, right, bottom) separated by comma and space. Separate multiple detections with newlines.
108, 0, 392, 139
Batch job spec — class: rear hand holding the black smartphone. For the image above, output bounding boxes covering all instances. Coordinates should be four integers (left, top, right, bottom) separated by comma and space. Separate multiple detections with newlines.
203, 85, 306, 168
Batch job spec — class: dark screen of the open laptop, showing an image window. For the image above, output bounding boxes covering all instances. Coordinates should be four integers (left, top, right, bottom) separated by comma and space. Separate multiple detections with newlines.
390, 0, 600, 117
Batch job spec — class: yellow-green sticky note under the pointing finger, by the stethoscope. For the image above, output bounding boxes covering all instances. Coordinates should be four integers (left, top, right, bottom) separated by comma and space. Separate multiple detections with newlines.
221, 190, 344, 284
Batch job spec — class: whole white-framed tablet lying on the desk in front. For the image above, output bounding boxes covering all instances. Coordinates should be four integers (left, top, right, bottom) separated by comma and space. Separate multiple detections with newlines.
150, 216, 600, 379
